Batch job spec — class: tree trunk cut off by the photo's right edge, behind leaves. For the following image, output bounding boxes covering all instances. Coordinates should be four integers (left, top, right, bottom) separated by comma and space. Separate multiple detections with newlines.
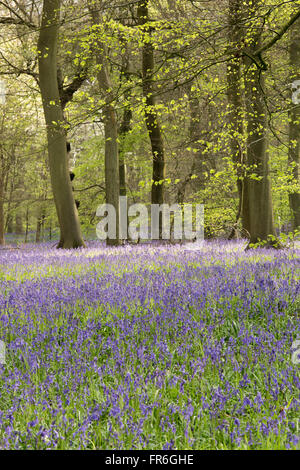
289, 11, 300, 230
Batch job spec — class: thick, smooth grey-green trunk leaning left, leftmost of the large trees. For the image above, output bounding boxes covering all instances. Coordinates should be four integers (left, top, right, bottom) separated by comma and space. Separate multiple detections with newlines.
38, 0, 84, 248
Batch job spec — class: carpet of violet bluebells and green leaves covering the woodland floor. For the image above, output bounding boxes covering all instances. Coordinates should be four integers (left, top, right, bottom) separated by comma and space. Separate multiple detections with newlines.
0, 242, 300, 450
